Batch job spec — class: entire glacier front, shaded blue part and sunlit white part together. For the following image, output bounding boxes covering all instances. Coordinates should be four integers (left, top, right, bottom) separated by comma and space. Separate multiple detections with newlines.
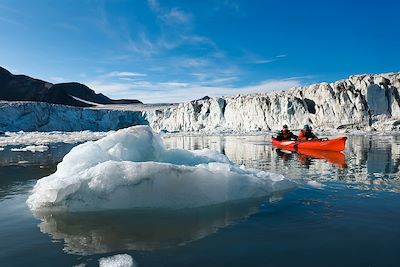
0, 72, 400, 133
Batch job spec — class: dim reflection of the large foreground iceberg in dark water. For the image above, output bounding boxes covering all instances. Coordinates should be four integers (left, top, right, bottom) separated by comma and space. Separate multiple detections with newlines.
35, 198, 281, 255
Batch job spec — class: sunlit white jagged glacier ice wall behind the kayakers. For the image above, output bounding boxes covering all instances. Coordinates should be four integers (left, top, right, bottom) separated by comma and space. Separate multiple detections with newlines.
145, 73, 400, 132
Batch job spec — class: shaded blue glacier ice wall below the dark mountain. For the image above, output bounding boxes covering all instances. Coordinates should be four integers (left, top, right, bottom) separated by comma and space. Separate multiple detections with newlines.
0, 101, 148, 131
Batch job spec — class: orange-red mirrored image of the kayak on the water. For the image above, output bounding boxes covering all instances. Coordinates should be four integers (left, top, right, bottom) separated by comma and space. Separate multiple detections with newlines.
276, 148, 347, 169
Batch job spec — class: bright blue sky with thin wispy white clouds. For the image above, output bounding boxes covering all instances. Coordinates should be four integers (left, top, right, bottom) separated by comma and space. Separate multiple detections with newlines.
0, 0, 400, 103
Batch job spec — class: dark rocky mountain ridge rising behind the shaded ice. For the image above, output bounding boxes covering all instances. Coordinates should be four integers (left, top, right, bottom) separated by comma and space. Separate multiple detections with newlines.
0, 67, 141, 107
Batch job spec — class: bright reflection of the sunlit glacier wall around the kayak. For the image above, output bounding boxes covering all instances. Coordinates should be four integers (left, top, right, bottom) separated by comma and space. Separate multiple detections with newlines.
164, 136, 400, 191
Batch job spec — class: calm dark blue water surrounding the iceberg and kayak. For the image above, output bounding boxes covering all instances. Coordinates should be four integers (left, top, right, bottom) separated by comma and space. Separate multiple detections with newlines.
0, 136, 400, 266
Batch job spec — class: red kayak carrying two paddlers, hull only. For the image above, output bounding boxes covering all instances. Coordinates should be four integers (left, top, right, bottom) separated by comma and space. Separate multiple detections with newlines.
272, 137, 347, 152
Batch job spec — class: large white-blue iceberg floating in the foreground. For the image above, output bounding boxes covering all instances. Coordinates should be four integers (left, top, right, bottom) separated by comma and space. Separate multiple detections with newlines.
27, 126, 293, 211
